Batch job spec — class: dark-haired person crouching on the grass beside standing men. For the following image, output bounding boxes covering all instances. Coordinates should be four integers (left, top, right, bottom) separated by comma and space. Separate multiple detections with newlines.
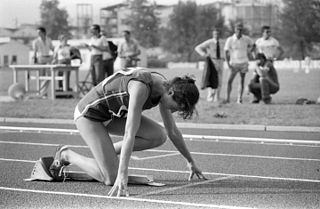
249, 53, 280, 104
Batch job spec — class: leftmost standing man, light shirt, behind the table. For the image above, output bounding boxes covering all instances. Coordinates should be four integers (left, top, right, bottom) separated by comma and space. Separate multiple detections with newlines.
32, 27, 54, 97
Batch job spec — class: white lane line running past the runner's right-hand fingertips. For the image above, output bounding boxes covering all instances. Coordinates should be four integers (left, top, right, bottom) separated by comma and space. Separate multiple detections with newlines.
0, 158, 320, 183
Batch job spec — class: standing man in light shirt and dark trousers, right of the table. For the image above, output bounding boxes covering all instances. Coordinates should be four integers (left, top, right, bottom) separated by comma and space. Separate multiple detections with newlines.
85, 24, 109, 86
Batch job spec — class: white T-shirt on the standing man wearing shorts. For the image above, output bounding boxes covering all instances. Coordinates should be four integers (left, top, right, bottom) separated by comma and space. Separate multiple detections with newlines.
224, 34, 253, 64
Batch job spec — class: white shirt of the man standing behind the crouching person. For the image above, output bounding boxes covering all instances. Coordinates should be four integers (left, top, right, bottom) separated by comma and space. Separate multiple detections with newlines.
256, 37, 279, 59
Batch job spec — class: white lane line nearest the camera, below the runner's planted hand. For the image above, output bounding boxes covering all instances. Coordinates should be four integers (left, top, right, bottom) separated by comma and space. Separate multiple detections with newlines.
0, 187, 253, 209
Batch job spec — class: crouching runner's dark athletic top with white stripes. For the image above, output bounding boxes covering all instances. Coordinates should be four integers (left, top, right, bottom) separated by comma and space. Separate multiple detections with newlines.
75, 68, 161, 122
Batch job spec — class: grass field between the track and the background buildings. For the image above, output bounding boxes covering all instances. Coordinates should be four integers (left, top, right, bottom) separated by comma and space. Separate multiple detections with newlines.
0, 66, 320, 127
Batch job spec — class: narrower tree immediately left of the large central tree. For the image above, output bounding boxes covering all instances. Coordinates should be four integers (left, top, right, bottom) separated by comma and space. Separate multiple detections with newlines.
125, 0, 160, 47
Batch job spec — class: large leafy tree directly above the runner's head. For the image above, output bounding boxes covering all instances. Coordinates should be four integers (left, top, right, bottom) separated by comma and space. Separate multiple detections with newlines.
162, 1, 226, 61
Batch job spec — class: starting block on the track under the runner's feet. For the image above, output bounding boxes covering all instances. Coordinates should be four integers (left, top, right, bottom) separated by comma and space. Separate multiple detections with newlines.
24, 157, 165, 187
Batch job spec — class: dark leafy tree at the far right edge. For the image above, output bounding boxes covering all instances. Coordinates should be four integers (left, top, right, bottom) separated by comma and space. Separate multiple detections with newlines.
281, 0, 320, 59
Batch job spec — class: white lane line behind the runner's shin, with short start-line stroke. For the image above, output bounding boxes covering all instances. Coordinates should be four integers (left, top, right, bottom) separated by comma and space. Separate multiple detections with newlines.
0, 141, 320, 162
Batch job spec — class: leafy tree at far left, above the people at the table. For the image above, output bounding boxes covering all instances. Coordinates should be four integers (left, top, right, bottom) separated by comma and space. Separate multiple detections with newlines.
40, 0, 70, 39
